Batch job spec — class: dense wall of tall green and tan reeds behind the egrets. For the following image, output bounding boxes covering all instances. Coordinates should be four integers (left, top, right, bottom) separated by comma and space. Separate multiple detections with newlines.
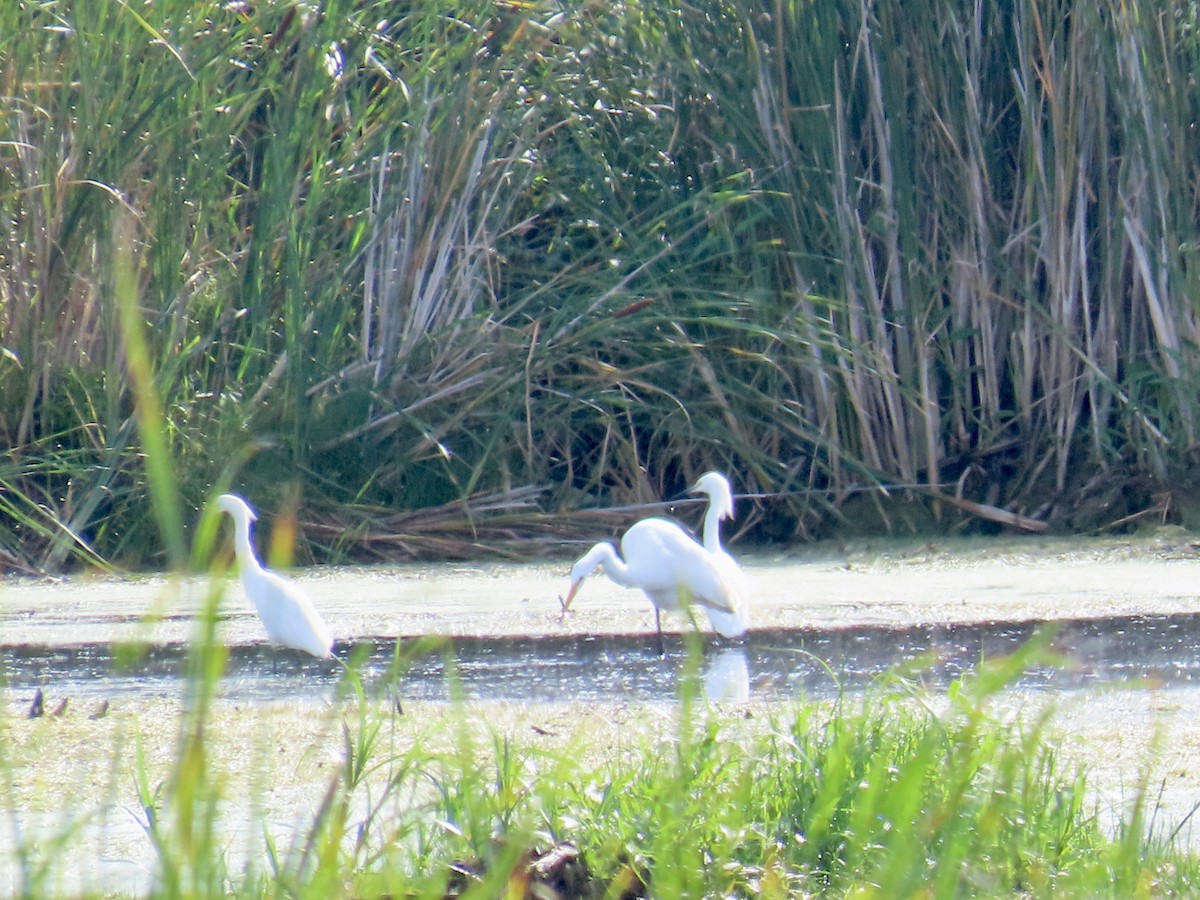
0, 0, 1200, 570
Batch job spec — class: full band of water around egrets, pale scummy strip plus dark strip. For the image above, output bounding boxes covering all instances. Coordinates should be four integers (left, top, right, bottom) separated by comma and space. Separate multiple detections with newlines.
7, 535, 1200, 704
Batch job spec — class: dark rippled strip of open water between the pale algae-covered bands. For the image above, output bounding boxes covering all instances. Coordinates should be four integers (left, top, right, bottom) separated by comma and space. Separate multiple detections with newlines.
0, 613, 1200, 703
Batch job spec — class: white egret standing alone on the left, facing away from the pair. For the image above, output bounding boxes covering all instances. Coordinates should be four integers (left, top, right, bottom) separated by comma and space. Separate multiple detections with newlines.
217, 493, 334, 658
